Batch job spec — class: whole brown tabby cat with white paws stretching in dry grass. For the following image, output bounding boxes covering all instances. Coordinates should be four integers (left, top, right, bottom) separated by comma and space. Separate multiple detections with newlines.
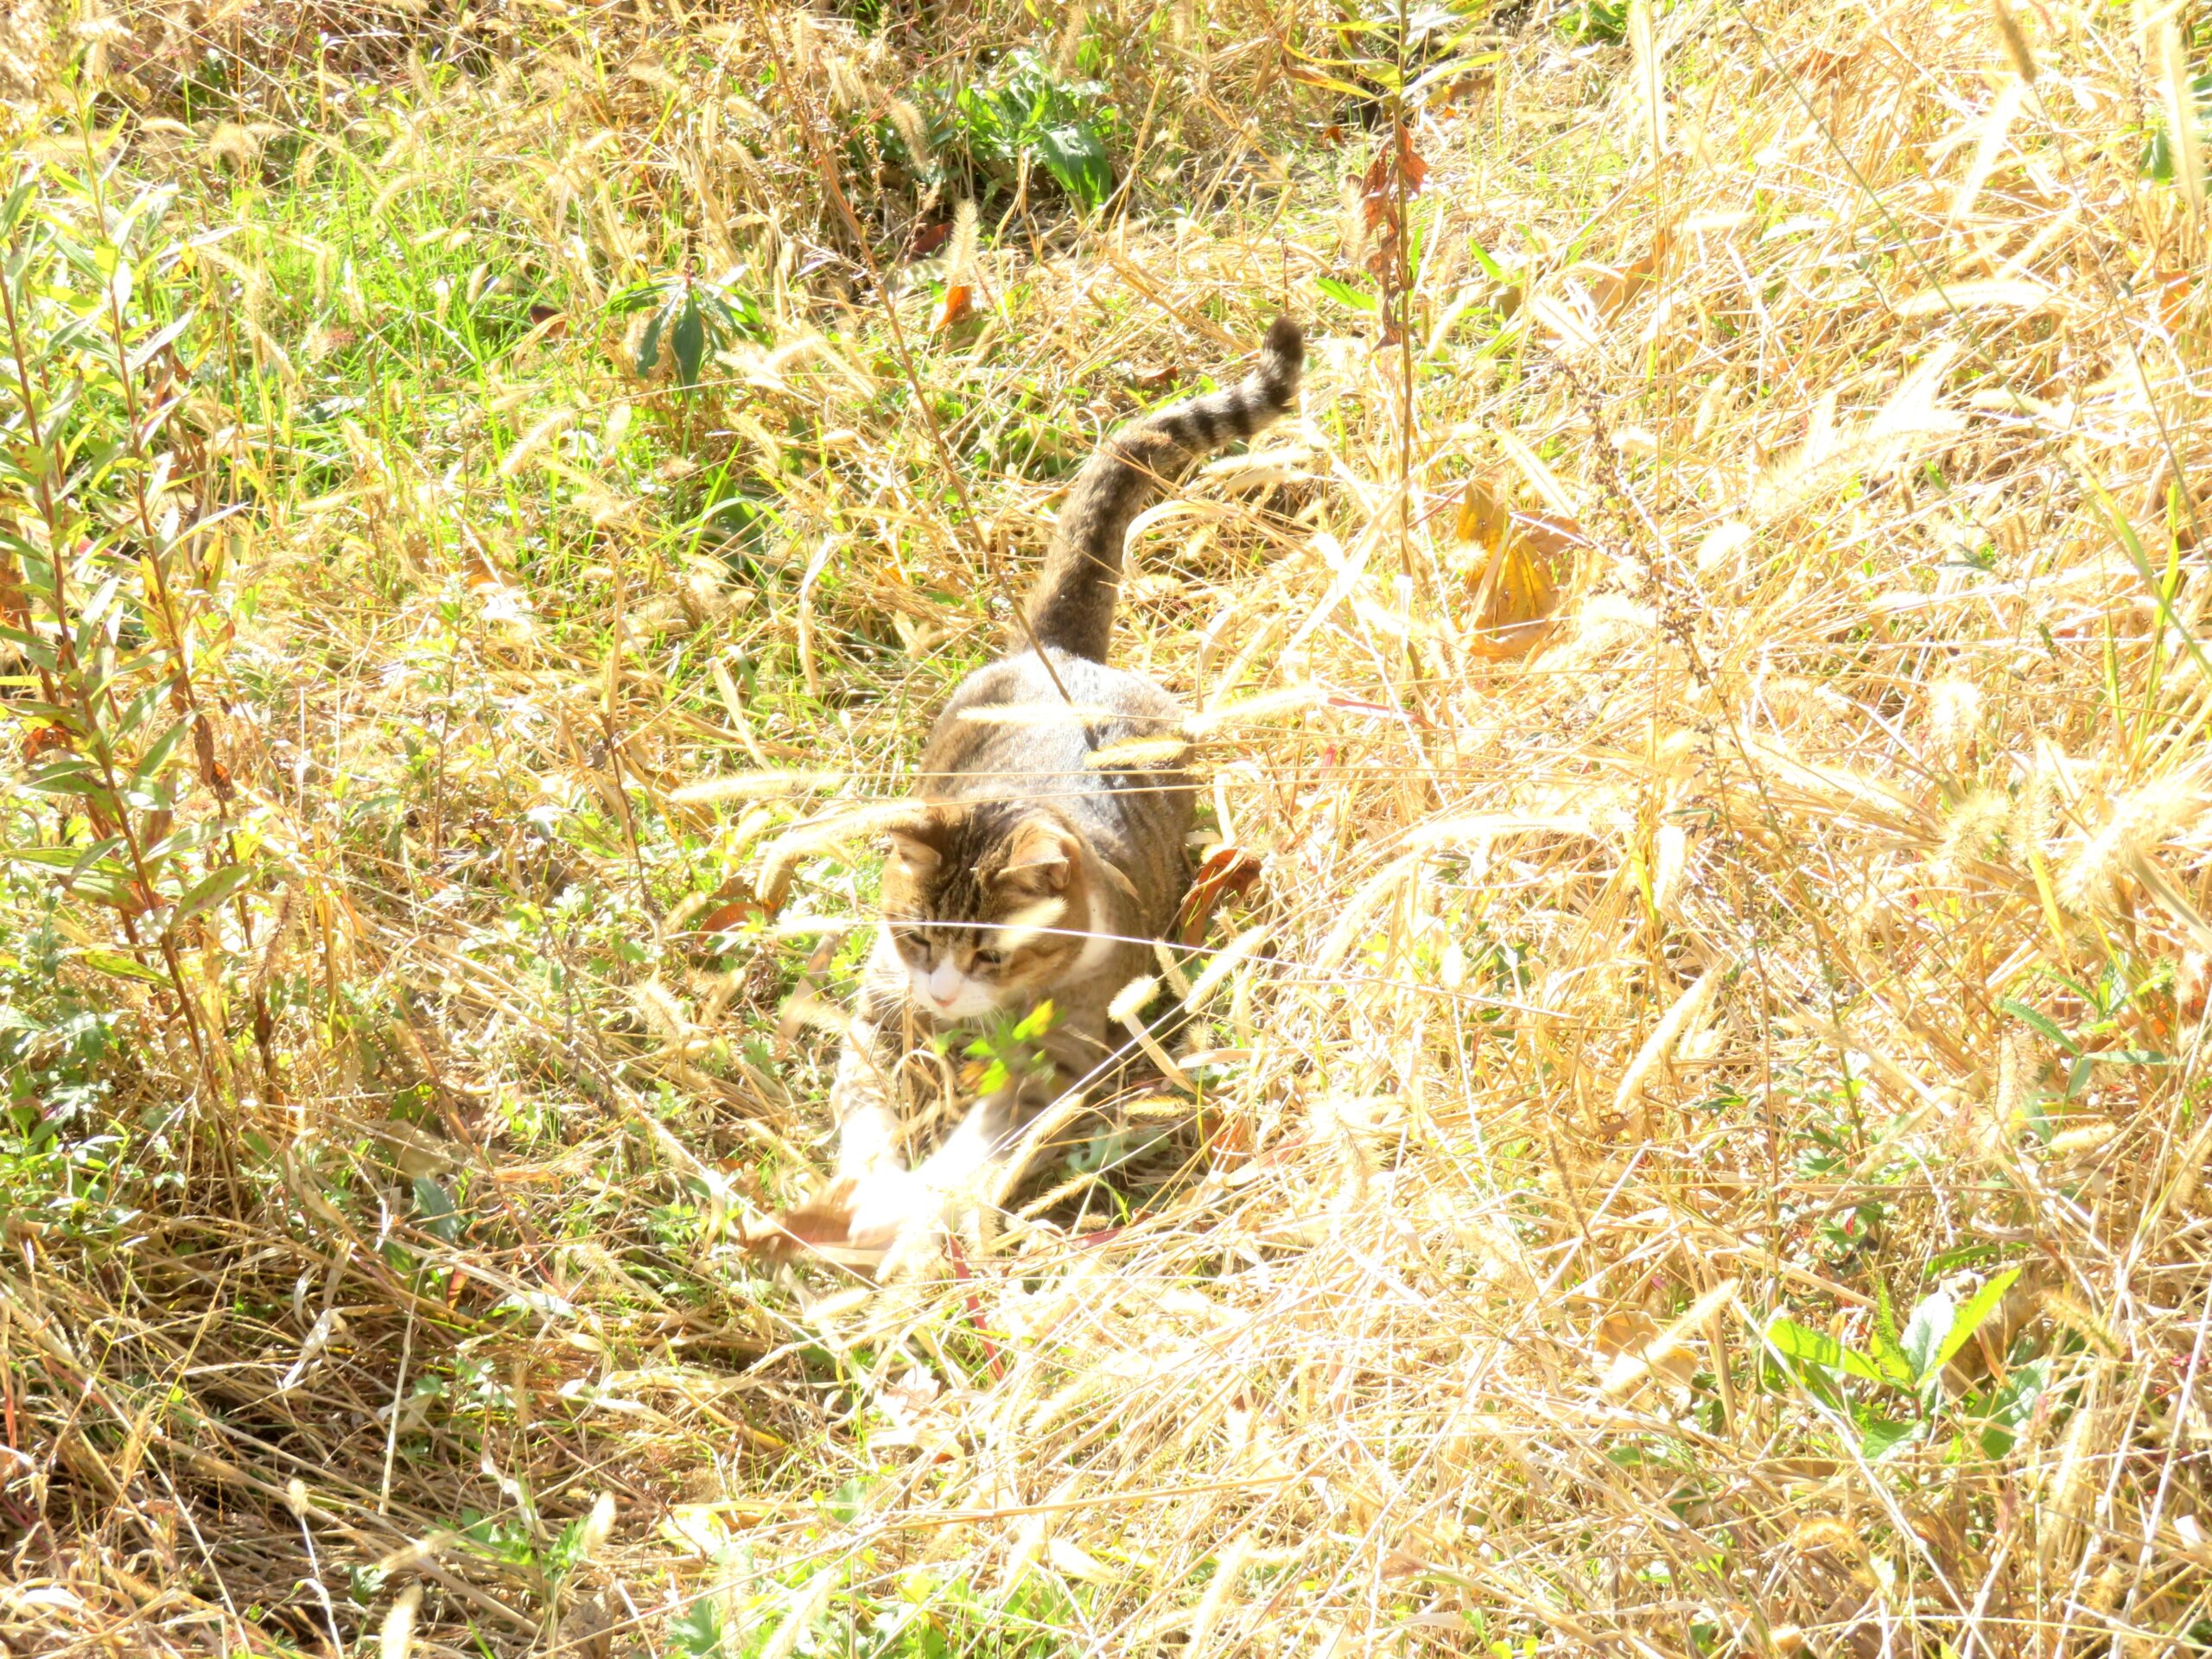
791, 319, 1305, 1248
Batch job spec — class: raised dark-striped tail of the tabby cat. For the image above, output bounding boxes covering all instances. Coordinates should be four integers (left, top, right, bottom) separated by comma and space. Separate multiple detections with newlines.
1028, 316, 1305, 661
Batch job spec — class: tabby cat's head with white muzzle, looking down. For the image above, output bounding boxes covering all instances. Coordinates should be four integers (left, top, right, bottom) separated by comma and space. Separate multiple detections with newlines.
882, 803, 1093, 1020
